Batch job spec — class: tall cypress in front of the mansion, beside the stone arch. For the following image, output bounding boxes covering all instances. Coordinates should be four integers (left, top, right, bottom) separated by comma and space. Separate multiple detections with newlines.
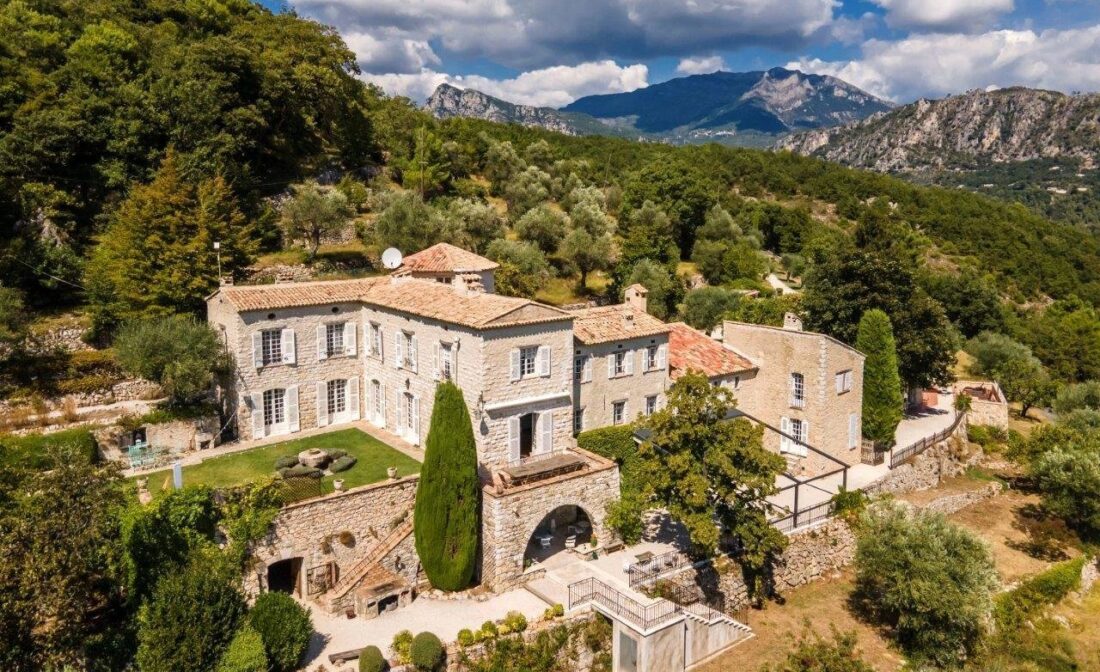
414, 383, 481, 591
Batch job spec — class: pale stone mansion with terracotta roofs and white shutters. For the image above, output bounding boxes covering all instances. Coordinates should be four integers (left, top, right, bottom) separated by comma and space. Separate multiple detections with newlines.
207, 244, 862, 588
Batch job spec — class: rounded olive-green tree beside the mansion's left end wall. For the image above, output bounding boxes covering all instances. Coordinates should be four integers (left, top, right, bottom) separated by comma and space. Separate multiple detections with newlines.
114, 315, 232, 405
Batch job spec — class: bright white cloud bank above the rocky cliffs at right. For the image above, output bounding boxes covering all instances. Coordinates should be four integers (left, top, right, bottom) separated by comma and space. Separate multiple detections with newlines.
788, 25, 1100, 101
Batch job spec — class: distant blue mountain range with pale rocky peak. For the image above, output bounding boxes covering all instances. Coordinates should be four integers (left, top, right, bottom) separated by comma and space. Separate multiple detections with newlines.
425, 68, 891, 145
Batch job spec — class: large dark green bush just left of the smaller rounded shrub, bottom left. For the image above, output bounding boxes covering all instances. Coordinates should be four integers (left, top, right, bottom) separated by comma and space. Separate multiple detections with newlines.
135, 548, 246, 672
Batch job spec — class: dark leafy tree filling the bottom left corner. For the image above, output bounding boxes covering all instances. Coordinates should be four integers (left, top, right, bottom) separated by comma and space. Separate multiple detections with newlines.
0, 446, 131, 672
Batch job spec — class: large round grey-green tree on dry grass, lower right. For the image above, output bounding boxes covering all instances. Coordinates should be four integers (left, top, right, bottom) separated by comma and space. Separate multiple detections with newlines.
856, 503, 999, 667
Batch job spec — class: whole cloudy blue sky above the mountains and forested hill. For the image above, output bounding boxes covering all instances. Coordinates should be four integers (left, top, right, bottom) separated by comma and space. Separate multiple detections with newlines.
262, 0, 1100, 107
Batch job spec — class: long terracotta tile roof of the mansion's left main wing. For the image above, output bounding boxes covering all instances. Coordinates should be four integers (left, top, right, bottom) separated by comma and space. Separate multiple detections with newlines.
216, 277, 573, 329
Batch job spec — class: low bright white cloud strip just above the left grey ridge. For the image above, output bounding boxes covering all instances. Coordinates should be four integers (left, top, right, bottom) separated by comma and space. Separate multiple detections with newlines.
363, 60, 649, 108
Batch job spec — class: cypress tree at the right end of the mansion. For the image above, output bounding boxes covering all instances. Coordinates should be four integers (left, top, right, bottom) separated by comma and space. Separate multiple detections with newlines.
856, 309, 904, 444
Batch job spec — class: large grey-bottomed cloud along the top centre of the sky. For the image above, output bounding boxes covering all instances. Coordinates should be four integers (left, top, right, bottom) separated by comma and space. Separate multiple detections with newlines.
290, 0, 840, 69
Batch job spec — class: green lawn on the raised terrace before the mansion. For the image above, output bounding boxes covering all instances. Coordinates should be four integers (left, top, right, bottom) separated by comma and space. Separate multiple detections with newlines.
142, 429, 420, 492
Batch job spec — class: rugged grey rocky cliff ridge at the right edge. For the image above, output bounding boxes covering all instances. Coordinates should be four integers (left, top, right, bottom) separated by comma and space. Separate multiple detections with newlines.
777, 88, 1100, 172
